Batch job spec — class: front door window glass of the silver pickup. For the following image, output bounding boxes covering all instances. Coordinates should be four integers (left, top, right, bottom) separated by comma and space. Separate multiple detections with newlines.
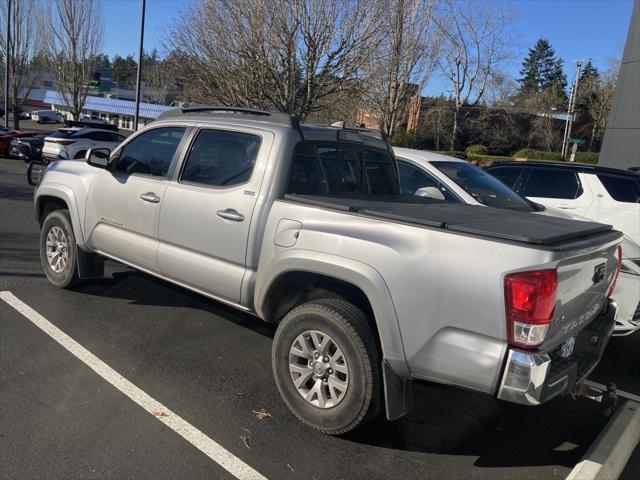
116, 127, 185, 177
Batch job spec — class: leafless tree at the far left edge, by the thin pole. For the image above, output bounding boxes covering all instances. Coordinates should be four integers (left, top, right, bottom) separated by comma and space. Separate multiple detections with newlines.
0, 0, 38, 130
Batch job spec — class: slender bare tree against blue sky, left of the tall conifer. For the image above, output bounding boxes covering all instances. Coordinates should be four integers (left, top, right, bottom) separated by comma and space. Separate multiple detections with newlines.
437, 0, 509, 150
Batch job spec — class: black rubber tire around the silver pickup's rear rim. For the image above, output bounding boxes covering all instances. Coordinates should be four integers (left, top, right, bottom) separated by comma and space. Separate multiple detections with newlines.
271, 298, 381, 435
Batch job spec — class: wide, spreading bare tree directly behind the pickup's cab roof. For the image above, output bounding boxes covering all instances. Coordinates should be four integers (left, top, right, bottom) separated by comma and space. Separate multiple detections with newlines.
166, 0, 382, 119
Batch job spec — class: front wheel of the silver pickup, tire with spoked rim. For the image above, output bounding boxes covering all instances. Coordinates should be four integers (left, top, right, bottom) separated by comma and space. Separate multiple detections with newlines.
40, 210, 80, 288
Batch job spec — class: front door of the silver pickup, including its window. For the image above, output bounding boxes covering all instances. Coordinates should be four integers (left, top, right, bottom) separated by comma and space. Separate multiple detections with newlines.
85, 127, 185, 272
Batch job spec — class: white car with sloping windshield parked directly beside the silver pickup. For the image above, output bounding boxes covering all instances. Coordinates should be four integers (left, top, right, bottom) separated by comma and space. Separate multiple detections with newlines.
393, 148, 640, 336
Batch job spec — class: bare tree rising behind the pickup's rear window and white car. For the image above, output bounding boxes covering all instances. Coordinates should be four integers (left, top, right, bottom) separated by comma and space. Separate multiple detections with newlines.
365, 0, 441, 137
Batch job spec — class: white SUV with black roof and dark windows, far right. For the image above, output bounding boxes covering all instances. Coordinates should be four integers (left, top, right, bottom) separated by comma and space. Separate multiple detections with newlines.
485, 162, 640, 248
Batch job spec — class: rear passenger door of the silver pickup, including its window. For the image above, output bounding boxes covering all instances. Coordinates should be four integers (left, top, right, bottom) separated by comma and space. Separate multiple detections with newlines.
158, 124, 273, 303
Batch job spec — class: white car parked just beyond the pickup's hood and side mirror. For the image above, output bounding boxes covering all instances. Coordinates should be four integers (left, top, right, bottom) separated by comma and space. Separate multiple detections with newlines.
42, 127, 125, 160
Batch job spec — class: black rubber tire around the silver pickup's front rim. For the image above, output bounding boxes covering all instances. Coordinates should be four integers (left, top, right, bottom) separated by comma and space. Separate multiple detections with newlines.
40, 210, 80, 288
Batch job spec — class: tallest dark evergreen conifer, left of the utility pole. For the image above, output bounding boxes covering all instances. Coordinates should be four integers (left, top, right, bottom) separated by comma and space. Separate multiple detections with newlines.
518, 38, 567, 102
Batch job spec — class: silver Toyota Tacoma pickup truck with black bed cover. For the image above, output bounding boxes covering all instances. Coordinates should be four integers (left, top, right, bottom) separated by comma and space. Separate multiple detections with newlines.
34, 107, 622, 434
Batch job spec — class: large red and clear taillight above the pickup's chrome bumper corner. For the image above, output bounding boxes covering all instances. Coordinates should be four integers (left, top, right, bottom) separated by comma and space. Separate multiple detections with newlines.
504, 270, 558, 348
